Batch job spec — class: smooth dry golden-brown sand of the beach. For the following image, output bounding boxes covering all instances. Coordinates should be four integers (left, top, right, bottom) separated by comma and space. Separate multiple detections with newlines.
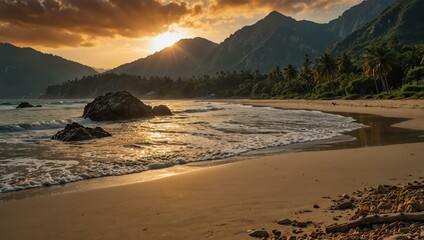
0, 100, 424, 240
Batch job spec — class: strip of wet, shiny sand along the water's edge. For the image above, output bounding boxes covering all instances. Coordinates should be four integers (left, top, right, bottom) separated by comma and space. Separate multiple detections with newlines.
0, 104, 424, 202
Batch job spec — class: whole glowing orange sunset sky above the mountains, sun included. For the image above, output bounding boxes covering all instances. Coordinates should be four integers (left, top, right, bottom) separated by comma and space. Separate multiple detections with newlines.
0, 0, 362, 69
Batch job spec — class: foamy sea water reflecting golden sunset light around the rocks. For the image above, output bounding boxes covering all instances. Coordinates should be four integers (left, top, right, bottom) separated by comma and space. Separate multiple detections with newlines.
0, 99, 365, 193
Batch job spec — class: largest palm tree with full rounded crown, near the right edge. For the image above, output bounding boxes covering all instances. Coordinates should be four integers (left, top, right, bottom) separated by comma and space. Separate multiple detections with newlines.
363, 46, 396, 92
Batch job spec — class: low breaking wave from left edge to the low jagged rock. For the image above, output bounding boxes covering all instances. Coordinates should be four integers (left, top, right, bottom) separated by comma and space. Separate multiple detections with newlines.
0, 118, 91, 132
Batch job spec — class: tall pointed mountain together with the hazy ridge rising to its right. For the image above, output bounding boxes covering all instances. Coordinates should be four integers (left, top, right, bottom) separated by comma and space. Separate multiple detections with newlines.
198, 0, 395, 74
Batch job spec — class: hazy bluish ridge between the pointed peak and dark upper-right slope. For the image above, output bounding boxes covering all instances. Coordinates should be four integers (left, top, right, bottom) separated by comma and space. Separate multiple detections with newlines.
327, 0, 396, 38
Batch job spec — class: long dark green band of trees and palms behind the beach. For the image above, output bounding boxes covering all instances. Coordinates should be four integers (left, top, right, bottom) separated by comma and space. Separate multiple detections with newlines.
42, 38, 424, 99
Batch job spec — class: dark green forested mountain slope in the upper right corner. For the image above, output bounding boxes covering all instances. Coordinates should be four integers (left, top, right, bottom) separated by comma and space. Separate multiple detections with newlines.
332, 0, 424, 57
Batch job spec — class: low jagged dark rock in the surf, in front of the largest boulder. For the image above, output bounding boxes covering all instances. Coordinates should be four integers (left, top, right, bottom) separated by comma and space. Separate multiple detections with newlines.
52, 123, 112, 142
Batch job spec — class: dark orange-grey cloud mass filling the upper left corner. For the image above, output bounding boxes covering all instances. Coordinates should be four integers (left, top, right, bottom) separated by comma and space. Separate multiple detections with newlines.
0, 0, 195, 47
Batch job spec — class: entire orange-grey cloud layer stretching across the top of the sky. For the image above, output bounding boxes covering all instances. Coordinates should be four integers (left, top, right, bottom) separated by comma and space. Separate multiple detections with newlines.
0, 0, 359, 48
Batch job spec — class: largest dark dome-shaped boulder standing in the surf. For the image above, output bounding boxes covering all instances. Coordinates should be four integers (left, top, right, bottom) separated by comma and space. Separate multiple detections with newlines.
83, 91, 153, 121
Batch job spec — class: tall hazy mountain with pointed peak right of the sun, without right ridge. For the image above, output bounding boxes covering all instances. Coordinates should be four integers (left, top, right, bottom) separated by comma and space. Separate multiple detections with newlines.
199, 11, 337, 74
